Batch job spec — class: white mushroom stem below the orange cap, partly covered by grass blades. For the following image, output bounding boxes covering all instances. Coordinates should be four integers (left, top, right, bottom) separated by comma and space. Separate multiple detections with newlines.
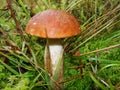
44, 39, 64, 90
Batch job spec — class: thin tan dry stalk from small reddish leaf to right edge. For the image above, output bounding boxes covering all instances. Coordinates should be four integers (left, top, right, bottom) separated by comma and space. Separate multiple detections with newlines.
80, 44, 120, 56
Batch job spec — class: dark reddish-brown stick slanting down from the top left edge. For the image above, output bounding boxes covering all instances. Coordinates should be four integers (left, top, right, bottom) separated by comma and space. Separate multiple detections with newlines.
6, 0, 25, 41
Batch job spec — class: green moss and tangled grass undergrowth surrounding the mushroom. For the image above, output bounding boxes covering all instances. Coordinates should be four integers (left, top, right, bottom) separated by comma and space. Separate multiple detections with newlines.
0, 0, 120, 90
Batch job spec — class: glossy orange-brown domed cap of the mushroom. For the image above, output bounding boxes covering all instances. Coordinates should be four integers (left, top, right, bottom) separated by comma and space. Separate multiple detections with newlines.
26, 9, 81, 38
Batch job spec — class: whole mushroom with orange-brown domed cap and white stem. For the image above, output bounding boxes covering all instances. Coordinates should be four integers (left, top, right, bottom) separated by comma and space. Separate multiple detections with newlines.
26, 9, 81, 90
